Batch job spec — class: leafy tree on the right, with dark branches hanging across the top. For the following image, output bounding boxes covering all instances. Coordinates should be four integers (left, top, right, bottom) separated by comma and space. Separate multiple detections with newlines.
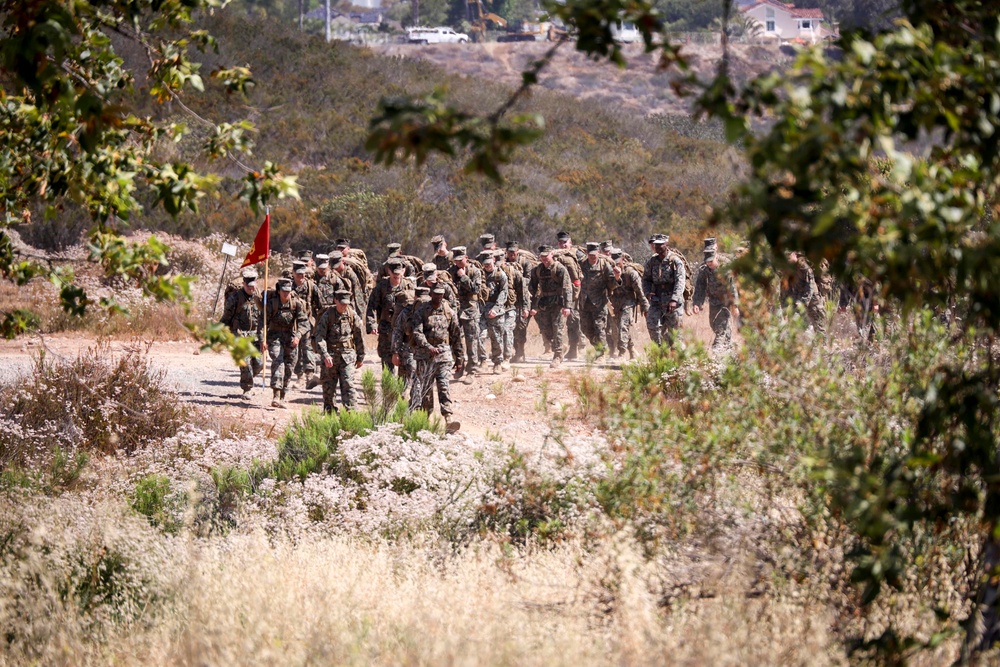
371, 0, 1000, 658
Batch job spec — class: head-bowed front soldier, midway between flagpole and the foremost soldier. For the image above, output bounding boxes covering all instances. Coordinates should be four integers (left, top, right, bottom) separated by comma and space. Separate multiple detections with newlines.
316, 290, 365, 412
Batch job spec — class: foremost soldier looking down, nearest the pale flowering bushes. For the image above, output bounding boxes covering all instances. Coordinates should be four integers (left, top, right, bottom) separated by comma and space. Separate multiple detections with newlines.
411, 288, 465, 420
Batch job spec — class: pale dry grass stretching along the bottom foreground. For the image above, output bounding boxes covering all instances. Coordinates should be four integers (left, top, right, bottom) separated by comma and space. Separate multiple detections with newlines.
0, 490, 844, 665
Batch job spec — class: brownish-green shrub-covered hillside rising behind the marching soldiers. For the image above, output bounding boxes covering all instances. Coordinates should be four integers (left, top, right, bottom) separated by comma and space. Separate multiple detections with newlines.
24, 12, 752, 260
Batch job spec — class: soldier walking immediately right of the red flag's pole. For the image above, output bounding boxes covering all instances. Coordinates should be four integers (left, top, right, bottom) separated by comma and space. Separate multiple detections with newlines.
261, 279, 309, 408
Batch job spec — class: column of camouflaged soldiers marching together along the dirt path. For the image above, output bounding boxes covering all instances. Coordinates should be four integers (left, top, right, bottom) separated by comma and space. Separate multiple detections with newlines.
222, 232, 756, 420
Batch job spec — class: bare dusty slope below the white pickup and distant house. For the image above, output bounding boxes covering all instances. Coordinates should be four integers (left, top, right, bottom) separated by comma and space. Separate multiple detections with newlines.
373, 42, 792, 114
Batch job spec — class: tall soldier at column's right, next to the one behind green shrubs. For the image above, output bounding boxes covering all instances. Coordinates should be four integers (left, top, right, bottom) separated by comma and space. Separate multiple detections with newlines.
642, 234, 686, 345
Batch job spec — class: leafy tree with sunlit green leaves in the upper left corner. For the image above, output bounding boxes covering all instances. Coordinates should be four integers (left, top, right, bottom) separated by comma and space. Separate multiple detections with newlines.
0, 0, 297, 366
